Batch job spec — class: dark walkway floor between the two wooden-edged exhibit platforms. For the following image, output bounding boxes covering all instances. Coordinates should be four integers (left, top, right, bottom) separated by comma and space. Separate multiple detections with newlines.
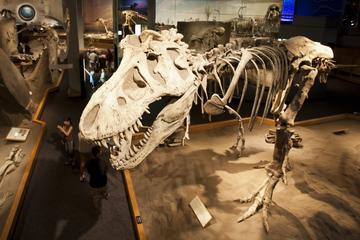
11, 80, 135, 240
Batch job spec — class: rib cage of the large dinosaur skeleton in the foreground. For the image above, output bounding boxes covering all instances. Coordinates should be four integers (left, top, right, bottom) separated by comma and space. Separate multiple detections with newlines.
202, 43, 289, 130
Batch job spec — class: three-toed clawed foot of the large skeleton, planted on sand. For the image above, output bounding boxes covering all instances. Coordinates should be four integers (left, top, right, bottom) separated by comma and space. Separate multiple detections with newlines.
236, 175, 279, 232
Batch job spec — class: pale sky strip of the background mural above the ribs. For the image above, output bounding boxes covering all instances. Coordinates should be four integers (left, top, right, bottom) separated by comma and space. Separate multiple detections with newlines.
156, 0, 282, 24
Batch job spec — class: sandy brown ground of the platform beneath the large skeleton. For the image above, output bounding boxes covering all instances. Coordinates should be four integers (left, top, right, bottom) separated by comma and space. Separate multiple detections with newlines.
131, 120, 360, 240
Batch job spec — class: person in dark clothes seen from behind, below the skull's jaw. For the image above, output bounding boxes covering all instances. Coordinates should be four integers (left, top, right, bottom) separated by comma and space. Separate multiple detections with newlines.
86, 146, 109, 208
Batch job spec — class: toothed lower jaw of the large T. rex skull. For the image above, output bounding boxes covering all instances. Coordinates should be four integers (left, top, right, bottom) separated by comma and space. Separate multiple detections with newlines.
102, 85, 195, 170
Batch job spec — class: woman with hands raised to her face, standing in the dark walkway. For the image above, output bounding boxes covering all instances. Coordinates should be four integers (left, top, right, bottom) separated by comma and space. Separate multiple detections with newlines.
57, 117, 75, 166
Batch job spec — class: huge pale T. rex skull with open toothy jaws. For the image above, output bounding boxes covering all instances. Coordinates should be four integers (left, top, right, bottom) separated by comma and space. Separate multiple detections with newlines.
79, 29, 197, 170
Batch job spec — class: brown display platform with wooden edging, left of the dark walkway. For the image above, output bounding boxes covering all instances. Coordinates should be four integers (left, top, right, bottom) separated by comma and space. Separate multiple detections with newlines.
0, 71, 64, 239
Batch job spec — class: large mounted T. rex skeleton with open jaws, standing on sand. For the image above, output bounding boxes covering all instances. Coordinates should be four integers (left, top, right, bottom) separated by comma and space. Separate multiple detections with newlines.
79, 29, 334, 230
